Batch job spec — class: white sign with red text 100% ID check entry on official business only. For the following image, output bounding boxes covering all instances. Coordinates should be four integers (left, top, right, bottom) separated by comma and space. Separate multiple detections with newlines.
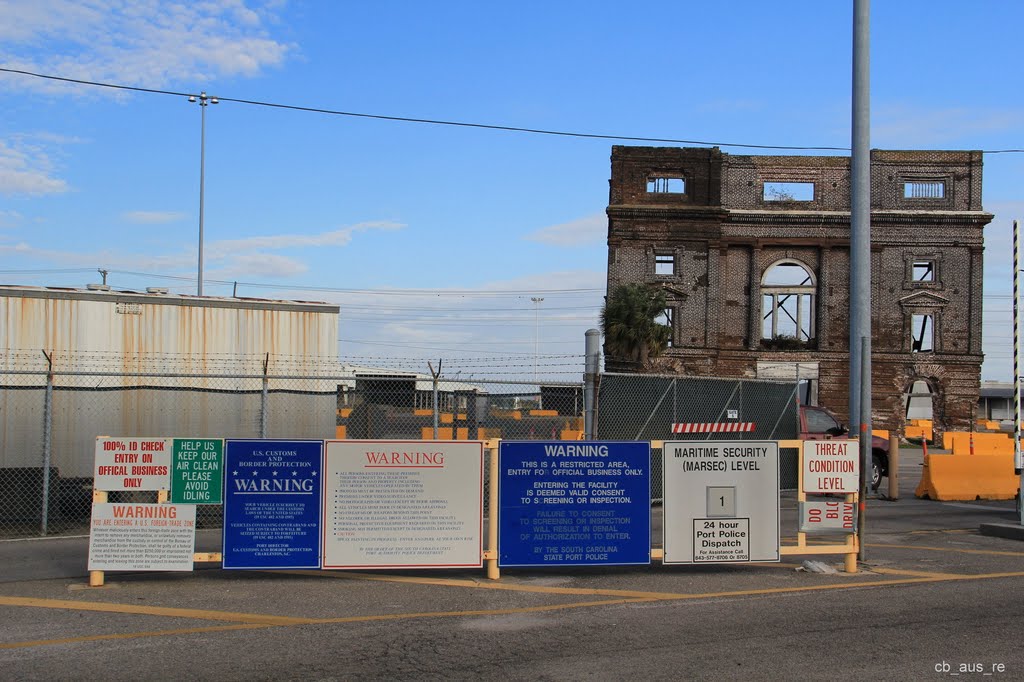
93, 436, 171, 491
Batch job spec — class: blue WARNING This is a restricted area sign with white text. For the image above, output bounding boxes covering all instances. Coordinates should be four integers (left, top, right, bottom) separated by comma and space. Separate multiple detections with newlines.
498, 441, 650, 566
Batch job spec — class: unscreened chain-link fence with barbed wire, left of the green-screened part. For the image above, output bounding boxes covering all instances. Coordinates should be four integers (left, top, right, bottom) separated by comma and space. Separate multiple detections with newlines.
0, 353, 584, 538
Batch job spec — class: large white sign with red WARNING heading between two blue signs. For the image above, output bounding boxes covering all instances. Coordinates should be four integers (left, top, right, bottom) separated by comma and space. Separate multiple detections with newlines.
322, 440, 483, 569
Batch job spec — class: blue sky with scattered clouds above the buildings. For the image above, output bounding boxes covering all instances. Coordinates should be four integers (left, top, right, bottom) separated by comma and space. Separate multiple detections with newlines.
0, 0, 1024, 380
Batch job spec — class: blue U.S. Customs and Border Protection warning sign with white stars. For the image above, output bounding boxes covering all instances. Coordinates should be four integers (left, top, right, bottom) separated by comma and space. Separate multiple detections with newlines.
222, 439, 324, 568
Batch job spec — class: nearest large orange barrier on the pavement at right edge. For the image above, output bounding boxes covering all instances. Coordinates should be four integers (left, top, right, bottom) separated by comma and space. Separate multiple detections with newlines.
913, 453, 1020, 500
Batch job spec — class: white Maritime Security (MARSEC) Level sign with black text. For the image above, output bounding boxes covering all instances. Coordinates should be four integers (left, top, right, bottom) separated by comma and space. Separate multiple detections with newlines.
664, 440, 779, 563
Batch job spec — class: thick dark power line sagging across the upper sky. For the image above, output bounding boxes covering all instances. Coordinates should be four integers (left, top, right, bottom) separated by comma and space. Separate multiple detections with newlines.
0, 68, 1024, 154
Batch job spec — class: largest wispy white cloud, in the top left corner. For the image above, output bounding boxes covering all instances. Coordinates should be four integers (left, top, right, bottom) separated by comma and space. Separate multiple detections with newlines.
0, 0, 295, 92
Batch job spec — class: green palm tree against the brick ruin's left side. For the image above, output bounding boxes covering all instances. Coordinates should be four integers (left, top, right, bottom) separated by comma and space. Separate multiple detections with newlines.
601, 284, 672, 367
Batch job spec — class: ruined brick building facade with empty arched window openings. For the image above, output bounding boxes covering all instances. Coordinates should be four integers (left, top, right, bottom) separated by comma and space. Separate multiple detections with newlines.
607, 146, 992, 431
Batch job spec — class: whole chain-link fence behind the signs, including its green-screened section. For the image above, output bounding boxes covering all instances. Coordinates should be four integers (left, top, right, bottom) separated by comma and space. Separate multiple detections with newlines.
0, 353, 797, 538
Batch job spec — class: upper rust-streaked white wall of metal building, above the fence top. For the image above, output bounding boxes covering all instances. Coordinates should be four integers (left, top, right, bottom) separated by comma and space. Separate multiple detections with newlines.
0, 287, 338, 373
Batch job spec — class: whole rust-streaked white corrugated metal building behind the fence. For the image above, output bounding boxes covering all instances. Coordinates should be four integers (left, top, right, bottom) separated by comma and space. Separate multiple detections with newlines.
0, 286, 339, 477
